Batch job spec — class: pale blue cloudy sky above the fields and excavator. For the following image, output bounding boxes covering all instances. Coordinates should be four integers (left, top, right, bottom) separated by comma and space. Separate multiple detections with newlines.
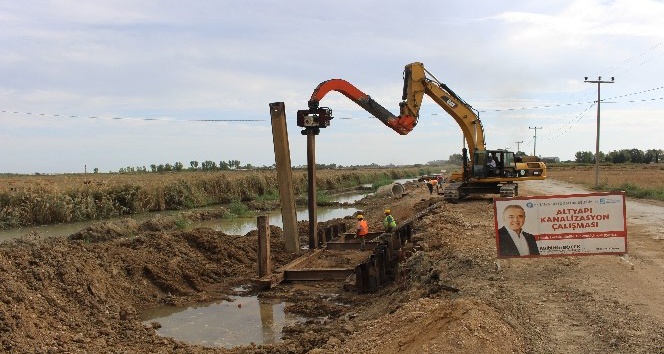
0, 0, 664, 173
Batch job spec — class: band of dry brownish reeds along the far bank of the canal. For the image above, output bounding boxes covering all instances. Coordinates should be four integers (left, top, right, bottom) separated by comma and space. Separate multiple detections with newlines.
0, 168, 428, 228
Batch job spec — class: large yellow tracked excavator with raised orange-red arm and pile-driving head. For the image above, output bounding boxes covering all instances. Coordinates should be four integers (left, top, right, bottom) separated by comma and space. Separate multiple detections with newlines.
297, 62, 546, 202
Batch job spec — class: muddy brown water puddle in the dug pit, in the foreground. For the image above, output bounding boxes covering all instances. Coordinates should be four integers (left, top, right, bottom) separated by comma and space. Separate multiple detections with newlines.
141, 296, 306, 348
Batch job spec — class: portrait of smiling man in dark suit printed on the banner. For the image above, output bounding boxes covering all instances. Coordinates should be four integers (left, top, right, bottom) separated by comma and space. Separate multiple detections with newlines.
498, 204, 539, 257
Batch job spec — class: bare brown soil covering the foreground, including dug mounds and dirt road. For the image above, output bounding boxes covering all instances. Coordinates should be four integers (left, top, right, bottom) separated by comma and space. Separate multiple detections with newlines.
0, 180, 664, 354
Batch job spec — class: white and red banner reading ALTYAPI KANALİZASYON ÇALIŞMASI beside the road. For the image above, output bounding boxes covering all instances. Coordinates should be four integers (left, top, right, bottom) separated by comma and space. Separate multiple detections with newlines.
493, 192, 627, 258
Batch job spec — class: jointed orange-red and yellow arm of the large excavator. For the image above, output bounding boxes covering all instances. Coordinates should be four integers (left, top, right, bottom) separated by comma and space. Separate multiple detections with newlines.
298, 62, 486, 152
